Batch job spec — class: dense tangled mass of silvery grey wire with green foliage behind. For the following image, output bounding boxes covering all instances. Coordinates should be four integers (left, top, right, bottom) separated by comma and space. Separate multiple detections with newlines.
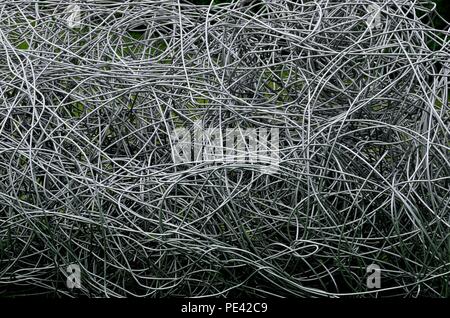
0, 0, 450, 297
